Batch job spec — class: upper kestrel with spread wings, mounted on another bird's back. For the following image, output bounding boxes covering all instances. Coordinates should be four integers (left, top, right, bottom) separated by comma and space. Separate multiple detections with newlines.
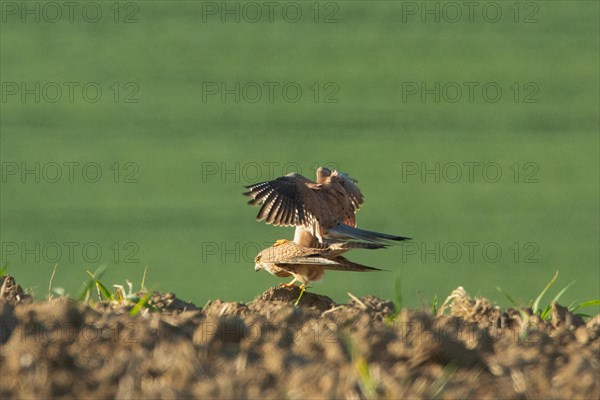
244, 167, 409, 247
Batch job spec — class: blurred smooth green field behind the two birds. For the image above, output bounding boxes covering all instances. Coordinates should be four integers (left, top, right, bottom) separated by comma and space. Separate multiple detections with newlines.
0, 1, 600, 307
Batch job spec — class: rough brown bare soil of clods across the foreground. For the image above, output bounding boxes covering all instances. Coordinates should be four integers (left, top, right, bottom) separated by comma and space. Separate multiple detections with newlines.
0, 276, 600, 399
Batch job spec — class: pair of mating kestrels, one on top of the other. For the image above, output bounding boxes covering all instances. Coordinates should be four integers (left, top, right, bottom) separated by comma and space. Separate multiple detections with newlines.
244, 167, 409, 291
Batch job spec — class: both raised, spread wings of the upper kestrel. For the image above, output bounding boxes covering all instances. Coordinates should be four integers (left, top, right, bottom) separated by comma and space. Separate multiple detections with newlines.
244, 171, 362, 236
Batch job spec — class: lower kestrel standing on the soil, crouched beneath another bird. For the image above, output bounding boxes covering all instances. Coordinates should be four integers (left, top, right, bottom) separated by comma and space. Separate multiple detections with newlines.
254, 239, 385, 289
